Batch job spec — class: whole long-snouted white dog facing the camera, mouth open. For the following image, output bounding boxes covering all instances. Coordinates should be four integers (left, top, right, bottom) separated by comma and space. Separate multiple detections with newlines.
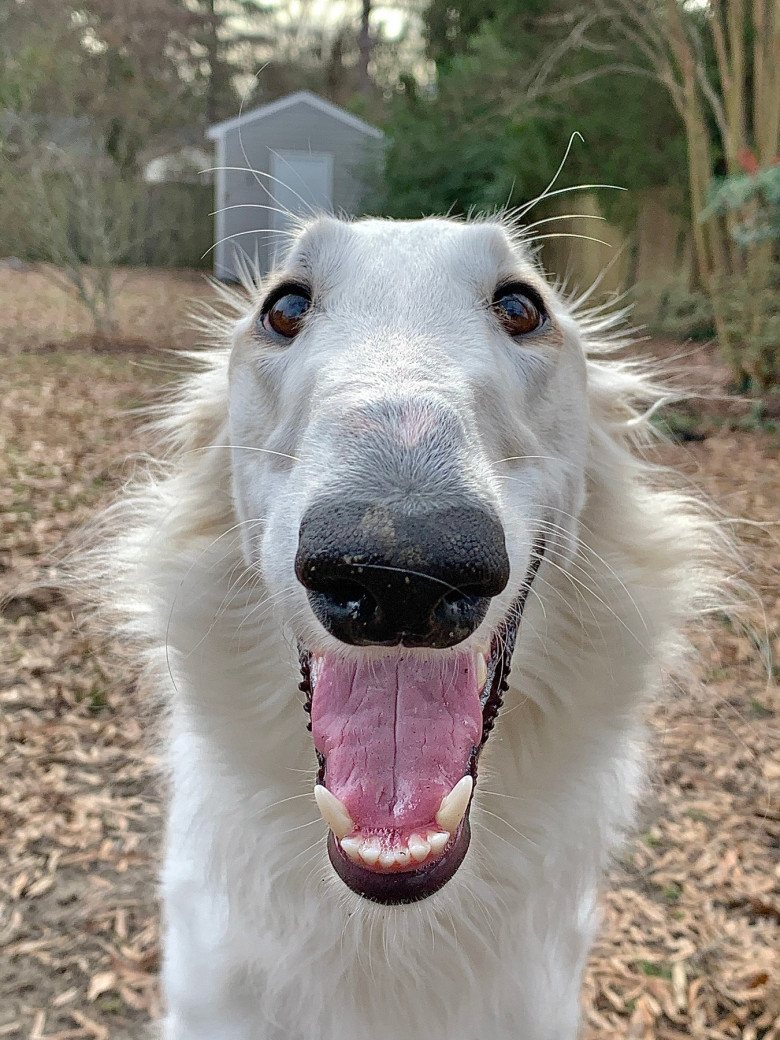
82, 217, 716, 1040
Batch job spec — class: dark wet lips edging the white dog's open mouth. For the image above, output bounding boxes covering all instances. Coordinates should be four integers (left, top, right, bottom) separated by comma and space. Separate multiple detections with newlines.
298, 542, 545, 906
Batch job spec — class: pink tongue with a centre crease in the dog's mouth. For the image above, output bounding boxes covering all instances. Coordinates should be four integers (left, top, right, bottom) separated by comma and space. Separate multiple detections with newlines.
311, 653, 483, 831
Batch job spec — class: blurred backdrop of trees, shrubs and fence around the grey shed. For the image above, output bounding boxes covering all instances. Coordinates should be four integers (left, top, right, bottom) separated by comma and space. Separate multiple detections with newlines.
0, 0, 780, 393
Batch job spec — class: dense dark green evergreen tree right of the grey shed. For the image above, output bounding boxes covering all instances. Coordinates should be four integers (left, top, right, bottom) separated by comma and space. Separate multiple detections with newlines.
381, 0, 684, 220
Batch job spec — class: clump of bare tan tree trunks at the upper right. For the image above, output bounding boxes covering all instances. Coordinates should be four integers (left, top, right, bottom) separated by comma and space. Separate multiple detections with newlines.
602, 0, 780, 391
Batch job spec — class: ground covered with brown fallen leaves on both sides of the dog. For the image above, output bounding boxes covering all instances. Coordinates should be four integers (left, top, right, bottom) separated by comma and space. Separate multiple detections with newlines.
0, 266, 780, 1040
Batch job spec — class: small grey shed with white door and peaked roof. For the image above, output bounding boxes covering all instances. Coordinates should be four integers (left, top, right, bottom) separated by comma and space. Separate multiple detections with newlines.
207, 90, 383, 280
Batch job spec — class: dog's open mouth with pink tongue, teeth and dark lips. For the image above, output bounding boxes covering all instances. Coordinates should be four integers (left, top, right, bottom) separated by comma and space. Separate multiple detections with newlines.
301, 548, 543, 904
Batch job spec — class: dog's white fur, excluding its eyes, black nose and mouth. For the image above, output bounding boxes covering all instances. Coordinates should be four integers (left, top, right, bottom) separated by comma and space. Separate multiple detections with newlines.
78, 218, 718, 1040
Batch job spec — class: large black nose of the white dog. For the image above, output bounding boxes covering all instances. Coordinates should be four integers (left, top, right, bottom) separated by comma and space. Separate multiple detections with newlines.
295, 499, 510, 647
